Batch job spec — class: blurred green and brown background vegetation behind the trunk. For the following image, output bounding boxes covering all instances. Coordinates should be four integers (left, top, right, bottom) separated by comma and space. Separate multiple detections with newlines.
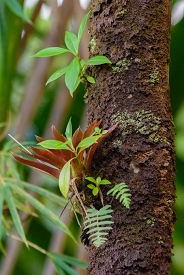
0, 0, 184, 275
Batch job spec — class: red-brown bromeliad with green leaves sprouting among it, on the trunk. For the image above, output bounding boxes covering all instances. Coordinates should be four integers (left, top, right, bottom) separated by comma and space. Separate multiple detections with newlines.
13, 120, 117, 207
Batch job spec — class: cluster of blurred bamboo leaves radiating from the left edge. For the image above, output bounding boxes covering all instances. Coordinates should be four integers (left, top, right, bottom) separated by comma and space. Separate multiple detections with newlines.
0, 146, 75, 251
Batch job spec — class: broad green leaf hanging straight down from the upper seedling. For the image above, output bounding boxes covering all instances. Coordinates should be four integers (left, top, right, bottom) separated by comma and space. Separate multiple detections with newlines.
65, 58, 80, 96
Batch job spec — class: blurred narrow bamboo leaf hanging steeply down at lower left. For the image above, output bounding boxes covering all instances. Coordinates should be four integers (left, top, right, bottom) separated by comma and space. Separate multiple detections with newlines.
4, 186, 28, 246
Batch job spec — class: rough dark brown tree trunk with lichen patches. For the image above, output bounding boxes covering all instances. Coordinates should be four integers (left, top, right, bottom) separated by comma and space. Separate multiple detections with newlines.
86, 0, 175, 275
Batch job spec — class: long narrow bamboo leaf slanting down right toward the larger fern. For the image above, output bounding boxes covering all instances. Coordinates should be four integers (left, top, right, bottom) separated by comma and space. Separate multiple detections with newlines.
8, 182, 76, 242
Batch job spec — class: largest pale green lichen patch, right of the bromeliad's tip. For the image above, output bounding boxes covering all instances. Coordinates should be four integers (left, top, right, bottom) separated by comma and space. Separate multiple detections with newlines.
111, 110, 168, 144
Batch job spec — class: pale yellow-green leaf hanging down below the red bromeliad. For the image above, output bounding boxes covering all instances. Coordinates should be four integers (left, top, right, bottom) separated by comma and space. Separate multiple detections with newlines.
59, 160, 71, 199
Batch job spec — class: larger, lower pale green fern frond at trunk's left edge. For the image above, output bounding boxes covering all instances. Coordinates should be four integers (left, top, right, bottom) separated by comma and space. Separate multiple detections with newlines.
84, 205, 113, 247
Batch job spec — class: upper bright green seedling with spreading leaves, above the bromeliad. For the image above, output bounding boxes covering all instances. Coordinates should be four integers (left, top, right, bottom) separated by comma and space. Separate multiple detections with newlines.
33, 12, 111, 96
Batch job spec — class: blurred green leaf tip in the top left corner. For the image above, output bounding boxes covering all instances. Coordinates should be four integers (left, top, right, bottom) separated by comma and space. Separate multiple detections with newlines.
5, 0, 32, 25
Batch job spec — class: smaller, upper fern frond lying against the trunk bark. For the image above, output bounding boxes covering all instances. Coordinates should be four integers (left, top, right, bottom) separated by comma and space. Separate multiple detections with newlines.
107, 182, 131, 208
